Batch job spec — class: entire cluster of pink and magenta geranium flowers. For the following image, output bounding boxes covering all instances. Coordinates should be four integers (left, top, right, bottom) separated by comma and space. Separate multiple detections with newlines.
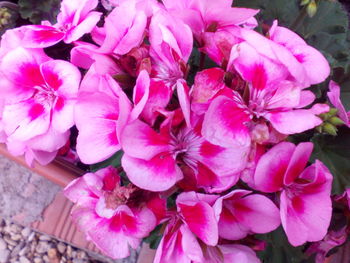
0, 0, 349, 263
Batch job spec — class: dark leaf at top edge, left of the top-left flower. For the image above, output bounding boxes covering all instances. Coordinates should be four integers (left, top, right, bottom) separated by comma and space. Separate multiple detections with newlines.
18, 0, 60, 24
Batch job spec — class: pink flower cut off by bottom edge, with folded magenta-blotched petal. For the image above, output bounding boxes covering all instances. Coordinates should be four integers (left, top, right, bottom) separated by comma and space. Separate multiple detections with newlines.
154, 192, 218, 263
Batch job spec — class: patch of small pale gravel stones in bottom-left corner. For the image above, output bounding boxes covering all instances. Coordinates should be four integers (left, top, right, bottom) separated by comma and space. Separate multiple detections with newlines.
0, 219, 108, 263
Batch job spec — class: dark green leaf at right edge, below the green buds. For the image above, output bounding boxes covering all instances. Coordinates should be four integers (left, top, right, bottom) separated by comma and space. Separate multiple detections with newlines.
311, 127, 350, 194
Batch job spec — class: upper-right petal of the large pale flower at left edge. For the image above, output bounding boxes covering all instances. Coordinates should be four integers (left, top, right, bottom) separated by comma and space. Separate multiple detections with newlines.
40, 60, 81, 99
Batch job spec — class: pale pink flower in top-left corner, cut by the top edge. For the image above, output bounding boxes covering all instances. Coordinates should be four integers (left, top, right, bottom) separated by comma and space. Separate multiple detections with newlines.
20, 0, 101, 48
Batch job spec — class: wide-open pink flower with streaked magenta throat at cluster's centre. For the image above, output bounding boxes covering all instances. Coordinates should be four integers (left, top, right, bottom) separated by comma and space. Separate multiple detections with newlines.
120, 81, 249, 192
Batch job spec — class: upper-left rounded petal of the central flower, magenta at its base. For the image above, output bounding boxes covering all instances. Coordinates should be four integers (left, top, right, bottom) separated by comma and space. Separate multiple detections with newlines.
120, 120, 171, 160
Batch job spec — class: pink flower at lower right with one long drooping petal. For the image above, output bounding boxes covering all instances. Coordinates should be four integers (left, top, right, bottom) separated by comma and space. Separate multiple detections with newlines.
254, 142, 332, 246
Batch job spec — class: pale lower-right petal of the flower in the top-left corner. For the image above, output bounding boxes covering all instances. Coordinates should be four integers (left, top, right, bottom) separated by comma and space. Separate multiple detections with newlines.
63, 12, 102, 44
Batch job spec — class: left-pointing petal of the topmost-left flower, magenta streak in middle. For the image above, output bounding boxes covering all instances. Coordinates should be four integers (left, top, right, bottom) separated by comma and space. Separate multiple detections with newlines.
21, 25, 65, 48
